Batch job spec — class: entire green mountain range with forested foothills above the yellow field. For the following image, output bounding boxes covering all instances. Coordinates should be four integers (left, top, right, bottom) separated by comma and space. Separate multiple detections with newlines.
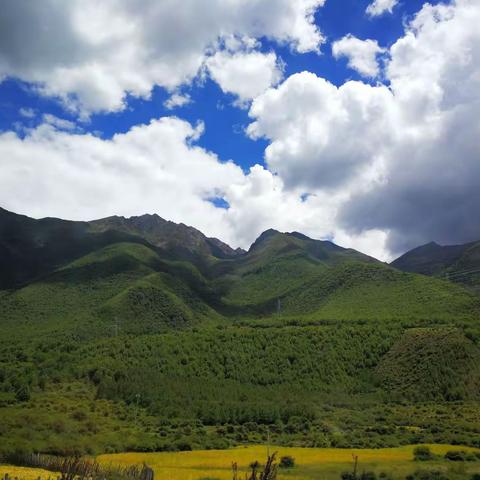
0, 209, 480, 453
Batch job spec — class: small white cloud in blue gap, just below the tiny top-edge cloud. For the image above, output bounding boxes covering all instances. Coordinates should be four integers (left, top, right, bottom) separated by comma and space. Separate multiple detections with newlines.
332, 35, 385, 78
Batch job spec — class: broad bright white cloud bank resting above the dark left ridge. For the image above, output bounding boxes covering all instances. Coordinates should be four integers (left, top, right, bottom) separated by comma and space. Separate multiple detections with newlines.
0, 117, 244, 238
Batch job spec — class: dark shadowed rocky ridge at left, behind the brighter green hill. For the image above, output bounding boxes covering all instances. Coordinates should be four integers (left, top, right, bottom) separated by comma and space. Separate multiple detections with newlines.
0, 208, 244, 289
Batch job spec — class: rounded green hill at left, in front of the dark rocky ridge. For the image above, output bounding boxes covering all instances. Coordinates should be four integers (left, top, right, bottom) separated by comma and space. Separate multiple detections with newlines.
0, 243, 221, 336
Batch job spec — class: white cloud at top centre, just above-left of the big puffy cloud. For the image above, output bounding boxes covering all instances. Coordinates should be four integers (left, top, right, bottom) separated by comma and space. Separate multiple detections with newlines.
206, 51, 283, 104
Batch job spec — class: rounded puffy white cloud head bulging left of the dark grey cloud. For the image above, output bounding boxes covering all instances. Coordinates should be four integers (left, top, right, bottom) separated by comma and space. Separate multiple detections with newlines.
247, 72, 392, 190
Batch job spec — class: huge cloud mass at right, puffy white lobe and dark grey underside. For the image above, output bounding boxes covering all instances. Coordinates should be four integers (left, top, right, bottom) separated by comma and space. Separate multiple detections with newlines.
248, 0, 480, 254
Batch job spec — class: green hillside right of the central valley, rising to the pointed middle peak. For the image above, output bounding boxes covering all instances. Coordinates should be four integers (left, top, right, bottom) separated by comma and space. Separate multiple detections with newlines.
220, 231, 479, 320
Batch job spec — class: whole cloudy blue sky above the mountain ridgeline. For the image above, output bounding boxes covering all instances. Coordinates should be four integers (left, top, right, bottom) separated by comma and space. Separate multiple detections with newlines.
0, 0, 480, 261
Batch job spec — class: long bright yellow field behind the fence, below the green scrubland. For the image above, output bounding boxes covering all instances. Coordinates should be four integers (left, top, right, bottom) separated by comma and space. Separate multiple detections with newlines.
98, 445, 480, 480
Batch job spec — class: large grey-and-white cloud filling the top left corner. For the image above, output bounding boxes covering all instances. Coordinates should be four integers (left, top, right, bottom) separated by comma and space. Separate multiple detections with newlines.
0, 0, 324, 115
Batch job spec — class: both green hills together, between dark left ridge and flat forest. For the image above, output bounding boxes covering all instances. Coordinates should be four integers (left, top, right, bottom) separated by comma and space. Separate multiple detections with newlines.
0, 225, 480, 342
